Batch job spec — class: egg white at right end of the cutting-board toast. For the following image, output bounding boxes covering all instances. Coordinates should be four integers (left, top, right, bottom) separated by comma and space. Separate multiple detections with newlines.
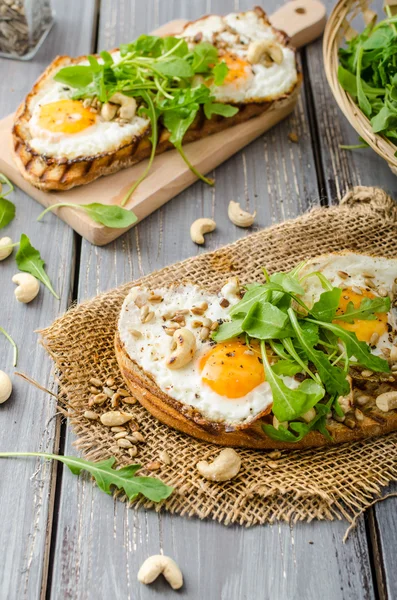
181, 11, 298, 103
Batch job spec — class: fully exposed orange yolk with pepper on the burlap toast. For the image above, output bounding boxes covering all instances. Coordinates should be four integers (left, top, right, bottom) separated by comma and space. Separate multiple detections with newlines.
199, 340, 265, 398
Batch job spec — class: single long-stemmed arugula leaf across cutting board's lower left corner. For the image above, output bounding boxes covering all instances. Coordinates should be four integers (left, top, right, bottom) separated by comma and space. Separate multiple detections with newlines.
37, 202, 138, 229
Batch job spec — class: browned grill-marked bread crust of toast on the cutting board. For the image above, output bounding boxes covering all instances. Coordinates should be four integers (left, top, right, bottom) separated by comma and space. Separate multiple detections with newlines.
12, 9, 302, 191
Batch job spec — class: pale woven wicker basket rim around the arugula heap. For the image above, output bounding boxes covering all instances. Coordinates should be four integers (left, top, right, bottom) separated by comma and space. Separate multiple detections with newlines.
323, 0, 397, 175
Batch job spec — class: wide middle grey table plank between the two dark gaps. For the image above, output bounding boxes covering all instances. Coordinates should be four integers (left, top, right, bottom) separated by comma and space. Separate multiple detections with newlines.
51, 0, 374, 600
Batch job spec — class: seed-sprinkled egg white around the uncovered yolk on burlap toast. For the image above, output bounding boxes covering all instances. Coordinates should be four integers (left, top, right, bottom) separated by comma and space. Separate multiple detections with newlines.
118, 284, 299, 426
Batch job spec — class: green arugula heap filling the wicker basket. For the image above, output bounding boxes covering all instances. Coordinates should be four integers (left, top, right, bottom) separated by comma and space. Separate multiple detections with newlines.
338, 7, 397, 149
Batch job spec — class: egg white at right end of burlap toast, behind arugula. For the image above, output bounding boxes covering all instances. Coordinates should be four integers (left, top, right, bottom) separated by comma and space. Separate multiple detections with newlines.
300, 252, 397, 356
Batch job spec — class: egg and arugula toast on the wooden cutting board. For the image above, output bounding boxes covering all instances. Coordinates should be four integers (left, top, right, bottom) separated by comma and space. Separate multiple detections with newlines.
13, 8, 301, 198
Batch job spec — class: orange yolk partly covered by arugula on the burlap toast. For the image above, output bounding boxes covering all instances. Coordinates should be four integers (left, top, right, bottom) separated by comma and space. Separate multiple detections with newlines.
334, 288, 387, 344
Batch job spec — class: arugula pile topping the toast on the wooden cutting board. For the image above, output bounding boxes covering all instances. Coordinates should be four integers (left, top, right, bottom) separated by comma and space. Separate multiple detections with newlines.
54, 35, 238, 206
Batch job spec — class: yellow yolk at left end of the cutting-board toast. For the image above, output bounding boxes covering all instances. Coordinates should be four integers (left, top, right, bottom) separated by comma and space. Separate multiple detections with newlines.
39, 99, 96, 134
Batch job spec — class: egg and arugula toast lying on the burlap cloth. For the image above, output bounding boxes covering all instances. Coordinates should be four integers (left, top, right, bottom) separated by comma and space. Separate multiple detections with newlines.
115, 253, 397, 448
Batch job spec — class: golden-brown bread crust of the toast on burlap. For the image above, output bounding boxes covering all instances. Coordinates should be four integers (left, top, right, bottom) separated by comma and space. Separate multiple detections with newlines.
115, 332, 397, 450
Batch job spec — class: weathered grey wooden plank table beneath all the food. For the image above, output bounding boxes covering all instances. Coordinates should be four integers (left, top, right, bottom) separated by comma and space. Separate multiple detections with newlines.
0, 0, 397, 600
